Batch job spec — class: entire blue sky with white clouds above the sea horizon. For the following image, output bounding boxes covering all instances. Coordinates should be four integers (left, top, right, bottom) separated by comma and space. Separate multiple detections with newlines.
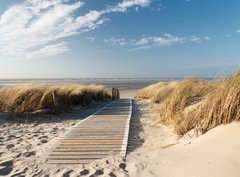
0, 0, 240, 78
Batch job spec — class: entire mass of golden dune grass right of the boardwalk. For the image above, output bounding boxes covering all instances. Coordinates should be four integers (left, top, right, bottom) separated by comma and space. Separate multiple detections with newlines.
137, 72, 240, 136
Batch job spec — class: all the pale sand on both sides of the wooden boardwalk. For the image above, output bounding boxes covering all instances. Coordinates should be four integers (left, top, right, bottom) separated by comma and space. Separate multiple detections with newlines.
0, 90, 240, 177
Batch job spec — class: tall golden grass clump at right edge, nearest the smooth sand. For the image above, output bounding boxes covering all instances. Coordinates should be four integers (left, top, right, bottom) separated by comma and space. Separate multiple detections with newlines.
192, 72, 240, 133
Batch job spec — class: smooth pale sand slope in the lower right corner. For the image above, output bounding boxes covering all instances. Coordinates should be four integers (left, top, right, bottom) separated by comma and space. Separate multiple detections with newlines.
128, 122, 240, 177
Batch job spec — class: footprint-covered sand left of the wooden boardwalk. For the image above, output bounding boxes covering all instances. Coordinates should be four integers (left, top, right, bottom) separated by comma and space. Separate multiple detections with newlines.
0, 102, 122, 176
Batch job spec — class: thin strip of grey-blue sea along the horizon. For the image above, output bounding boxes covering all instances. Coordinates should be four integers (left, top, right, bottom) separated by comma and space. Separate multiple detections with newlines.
0, 78, 177, 89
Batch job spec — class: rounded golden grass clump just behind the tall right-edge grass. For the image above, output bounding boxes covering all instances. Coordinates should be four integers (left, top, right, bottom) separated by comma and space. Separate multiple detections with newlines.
158, 79, 216, 135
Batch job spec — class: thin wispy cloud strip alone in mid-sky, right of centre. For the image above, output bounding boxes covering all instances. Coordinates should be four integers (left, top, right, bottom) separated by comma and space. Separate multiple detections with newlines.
104, 33, 184, 50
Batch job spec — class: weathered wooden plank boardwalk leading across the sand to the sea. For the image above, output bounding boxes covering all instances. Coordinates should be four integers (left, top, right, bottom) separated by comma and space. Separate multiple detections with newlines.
47, 99, 132, 165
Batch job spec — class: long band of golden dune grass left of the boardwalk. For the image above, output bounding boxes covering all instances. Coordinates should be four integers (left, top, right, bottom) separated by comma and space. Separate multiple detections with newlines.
0, 84, 110, 114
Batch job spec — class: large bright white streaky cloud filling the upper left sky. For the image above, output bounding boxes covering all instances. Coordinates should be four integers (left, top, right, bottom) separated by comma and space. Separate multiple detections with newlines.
0, 0, 150, 58
